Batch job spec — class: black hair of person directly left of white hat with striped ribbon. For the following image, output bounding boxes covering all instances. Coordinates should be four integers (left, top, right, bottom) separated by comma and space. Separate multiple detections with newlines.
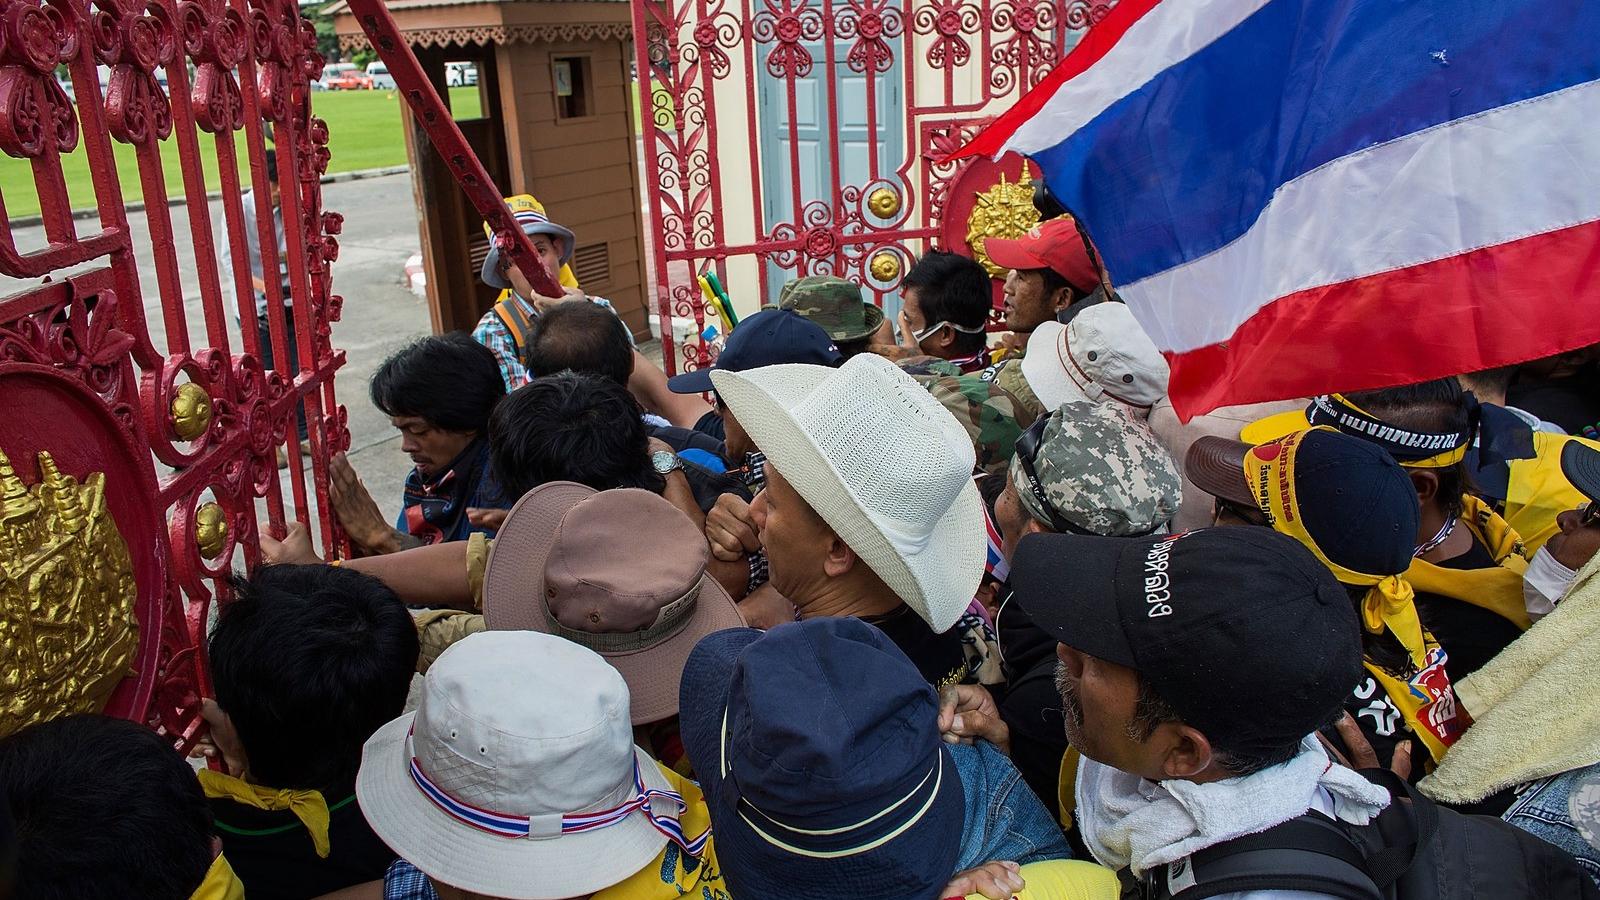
210, 565, 418, 791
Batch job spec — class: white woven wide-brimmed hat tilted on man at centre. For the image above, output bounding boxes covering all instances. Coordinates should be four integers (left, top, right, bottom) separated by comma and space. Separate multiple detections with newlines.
710, 354, 987, 633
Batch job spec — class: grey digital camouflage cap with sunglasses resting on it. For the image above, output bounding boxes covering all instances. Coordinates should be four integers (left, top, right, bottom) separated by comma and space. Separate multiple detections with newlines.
1011, 397, 1182, 536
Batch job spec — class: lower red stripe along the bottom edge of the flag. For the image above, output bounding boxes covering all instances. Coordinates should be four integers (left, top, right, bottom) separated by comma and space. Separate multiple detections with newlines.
1166, 221, 1600, 421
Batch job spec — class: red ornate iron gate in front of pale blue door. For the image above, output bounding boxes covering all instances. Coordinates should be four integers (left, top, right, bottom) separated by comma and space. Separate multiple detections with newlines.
634, 0, 1115, 368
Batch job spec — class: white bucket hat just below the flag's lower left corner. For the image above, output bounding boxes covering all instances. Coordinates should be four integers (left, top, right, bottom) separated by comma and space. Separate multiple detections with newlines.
1022, 303, 1170, 410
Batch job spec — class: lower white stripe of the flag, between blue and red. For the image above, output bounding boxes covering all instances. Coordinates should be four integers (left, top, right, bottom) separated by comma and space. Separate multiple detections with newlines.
1112, 82, 1600, 352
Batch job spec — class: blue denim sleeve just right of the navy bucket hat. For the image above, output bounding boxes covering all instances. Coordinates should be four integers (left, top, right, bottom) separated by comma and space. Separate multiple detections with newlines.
950, 741, 1072, 871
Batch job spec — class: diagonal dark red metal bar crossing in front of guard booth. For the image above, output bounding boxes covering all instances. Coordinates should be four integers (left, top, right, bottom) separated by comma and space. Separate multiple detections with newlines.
337, 0, 562, 296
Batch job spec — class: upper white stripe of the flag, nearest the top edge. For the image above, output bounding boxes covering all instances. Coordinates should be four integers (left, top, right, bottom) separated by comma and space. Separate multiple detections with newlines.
995, 0, 1270, 157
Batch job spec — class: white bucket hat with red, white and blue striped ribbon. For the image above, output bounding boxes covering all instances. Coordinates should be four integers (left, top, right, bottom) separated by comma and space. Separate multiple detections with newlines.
355, 631, 706, 900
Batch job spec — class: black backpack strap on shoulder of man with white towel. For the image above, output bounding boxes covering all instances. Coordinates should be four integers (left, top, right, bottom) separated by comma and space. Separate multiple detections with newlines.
1144, 812, 1382, 900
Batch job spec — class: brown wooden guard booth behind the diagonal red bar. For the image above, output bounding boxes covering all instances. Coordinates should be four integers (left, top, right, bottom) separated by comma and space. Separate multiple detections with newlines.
330, 0, 648, 338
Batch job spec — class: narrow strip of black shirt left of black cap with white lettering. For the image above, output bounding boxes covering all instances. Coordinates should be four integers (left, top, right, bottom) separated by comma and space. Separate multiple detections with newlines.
995, 588, 1067, 818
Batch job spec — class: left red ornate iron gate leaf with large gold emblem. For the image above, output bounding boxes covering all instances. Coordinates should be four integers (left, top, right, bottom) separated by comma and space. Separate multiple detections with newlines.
0, 0, 349, 745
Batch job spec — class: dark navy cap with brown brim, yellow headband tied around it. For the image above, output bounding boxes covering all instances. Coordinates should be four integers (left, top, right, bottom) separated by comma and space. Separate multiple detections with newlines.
1184, 428, 1421, 575
